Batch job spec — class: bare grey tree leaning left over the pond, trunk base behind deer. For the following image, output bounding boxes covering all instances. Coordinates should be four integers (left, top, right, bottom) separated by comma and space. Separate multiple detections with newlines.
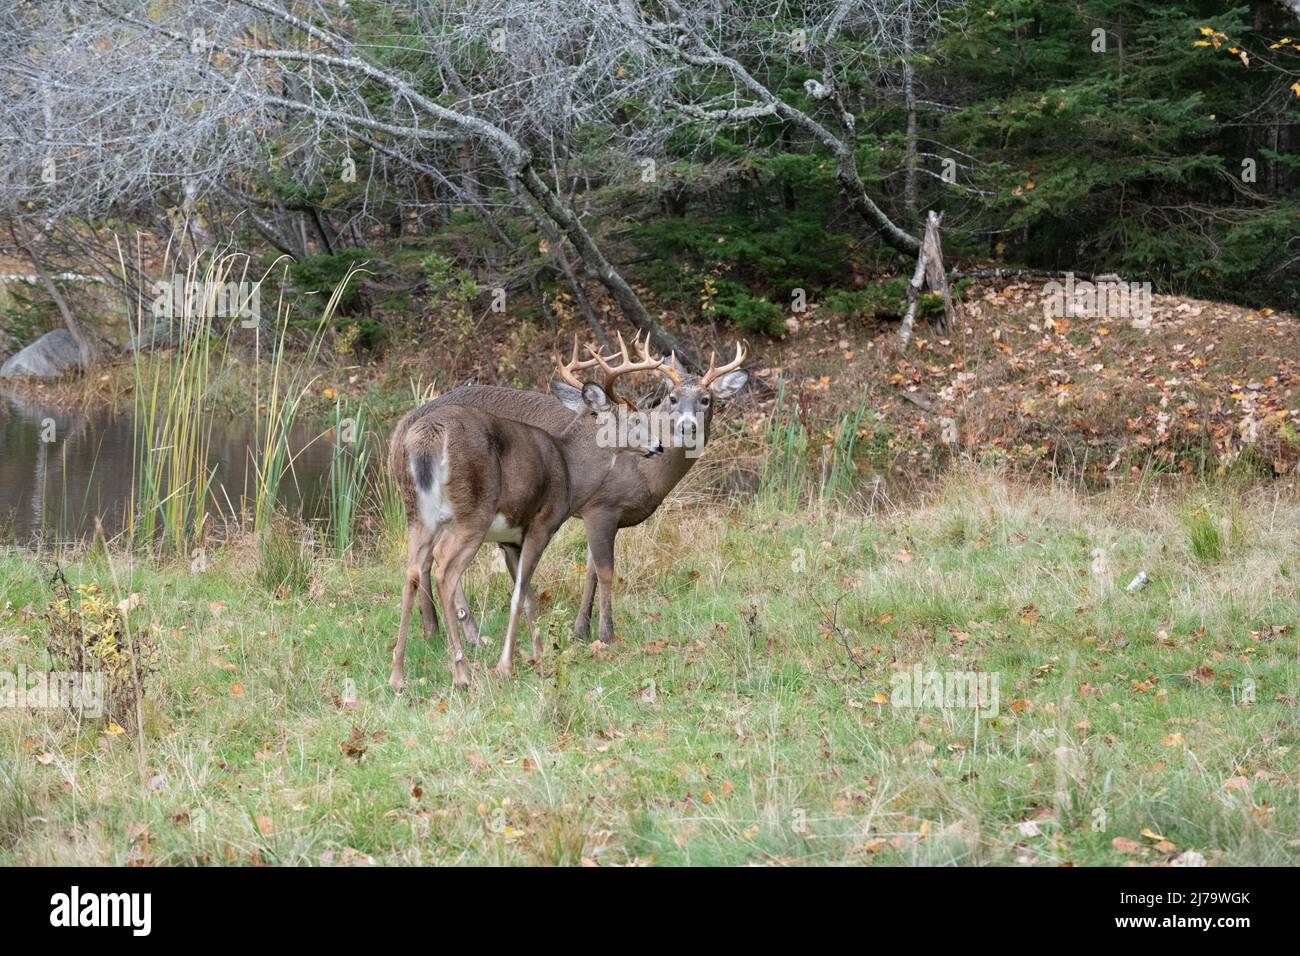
0, 0, 699, 368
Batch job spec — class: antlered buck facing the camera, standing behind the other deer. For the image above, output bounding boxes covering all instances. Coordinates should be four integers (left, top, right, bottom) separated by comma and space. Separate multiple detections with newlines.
410, 334, 749, 655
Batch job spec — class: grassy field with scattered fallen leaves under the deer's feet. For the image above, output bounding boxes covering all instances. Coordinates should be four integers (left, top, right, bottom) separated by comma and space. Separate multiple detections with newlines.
0, 473, 1300, 865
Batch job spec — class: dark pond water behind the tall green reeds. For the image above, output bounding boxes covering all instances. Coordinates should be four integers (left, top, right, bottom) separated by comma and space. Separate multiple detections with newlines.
0, 390, 333, 546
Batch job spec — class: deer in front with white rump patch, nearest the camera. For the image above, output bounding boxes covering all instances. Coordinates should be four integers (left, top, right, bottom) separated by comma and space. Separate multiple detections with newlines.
389, 349, 663, 692
